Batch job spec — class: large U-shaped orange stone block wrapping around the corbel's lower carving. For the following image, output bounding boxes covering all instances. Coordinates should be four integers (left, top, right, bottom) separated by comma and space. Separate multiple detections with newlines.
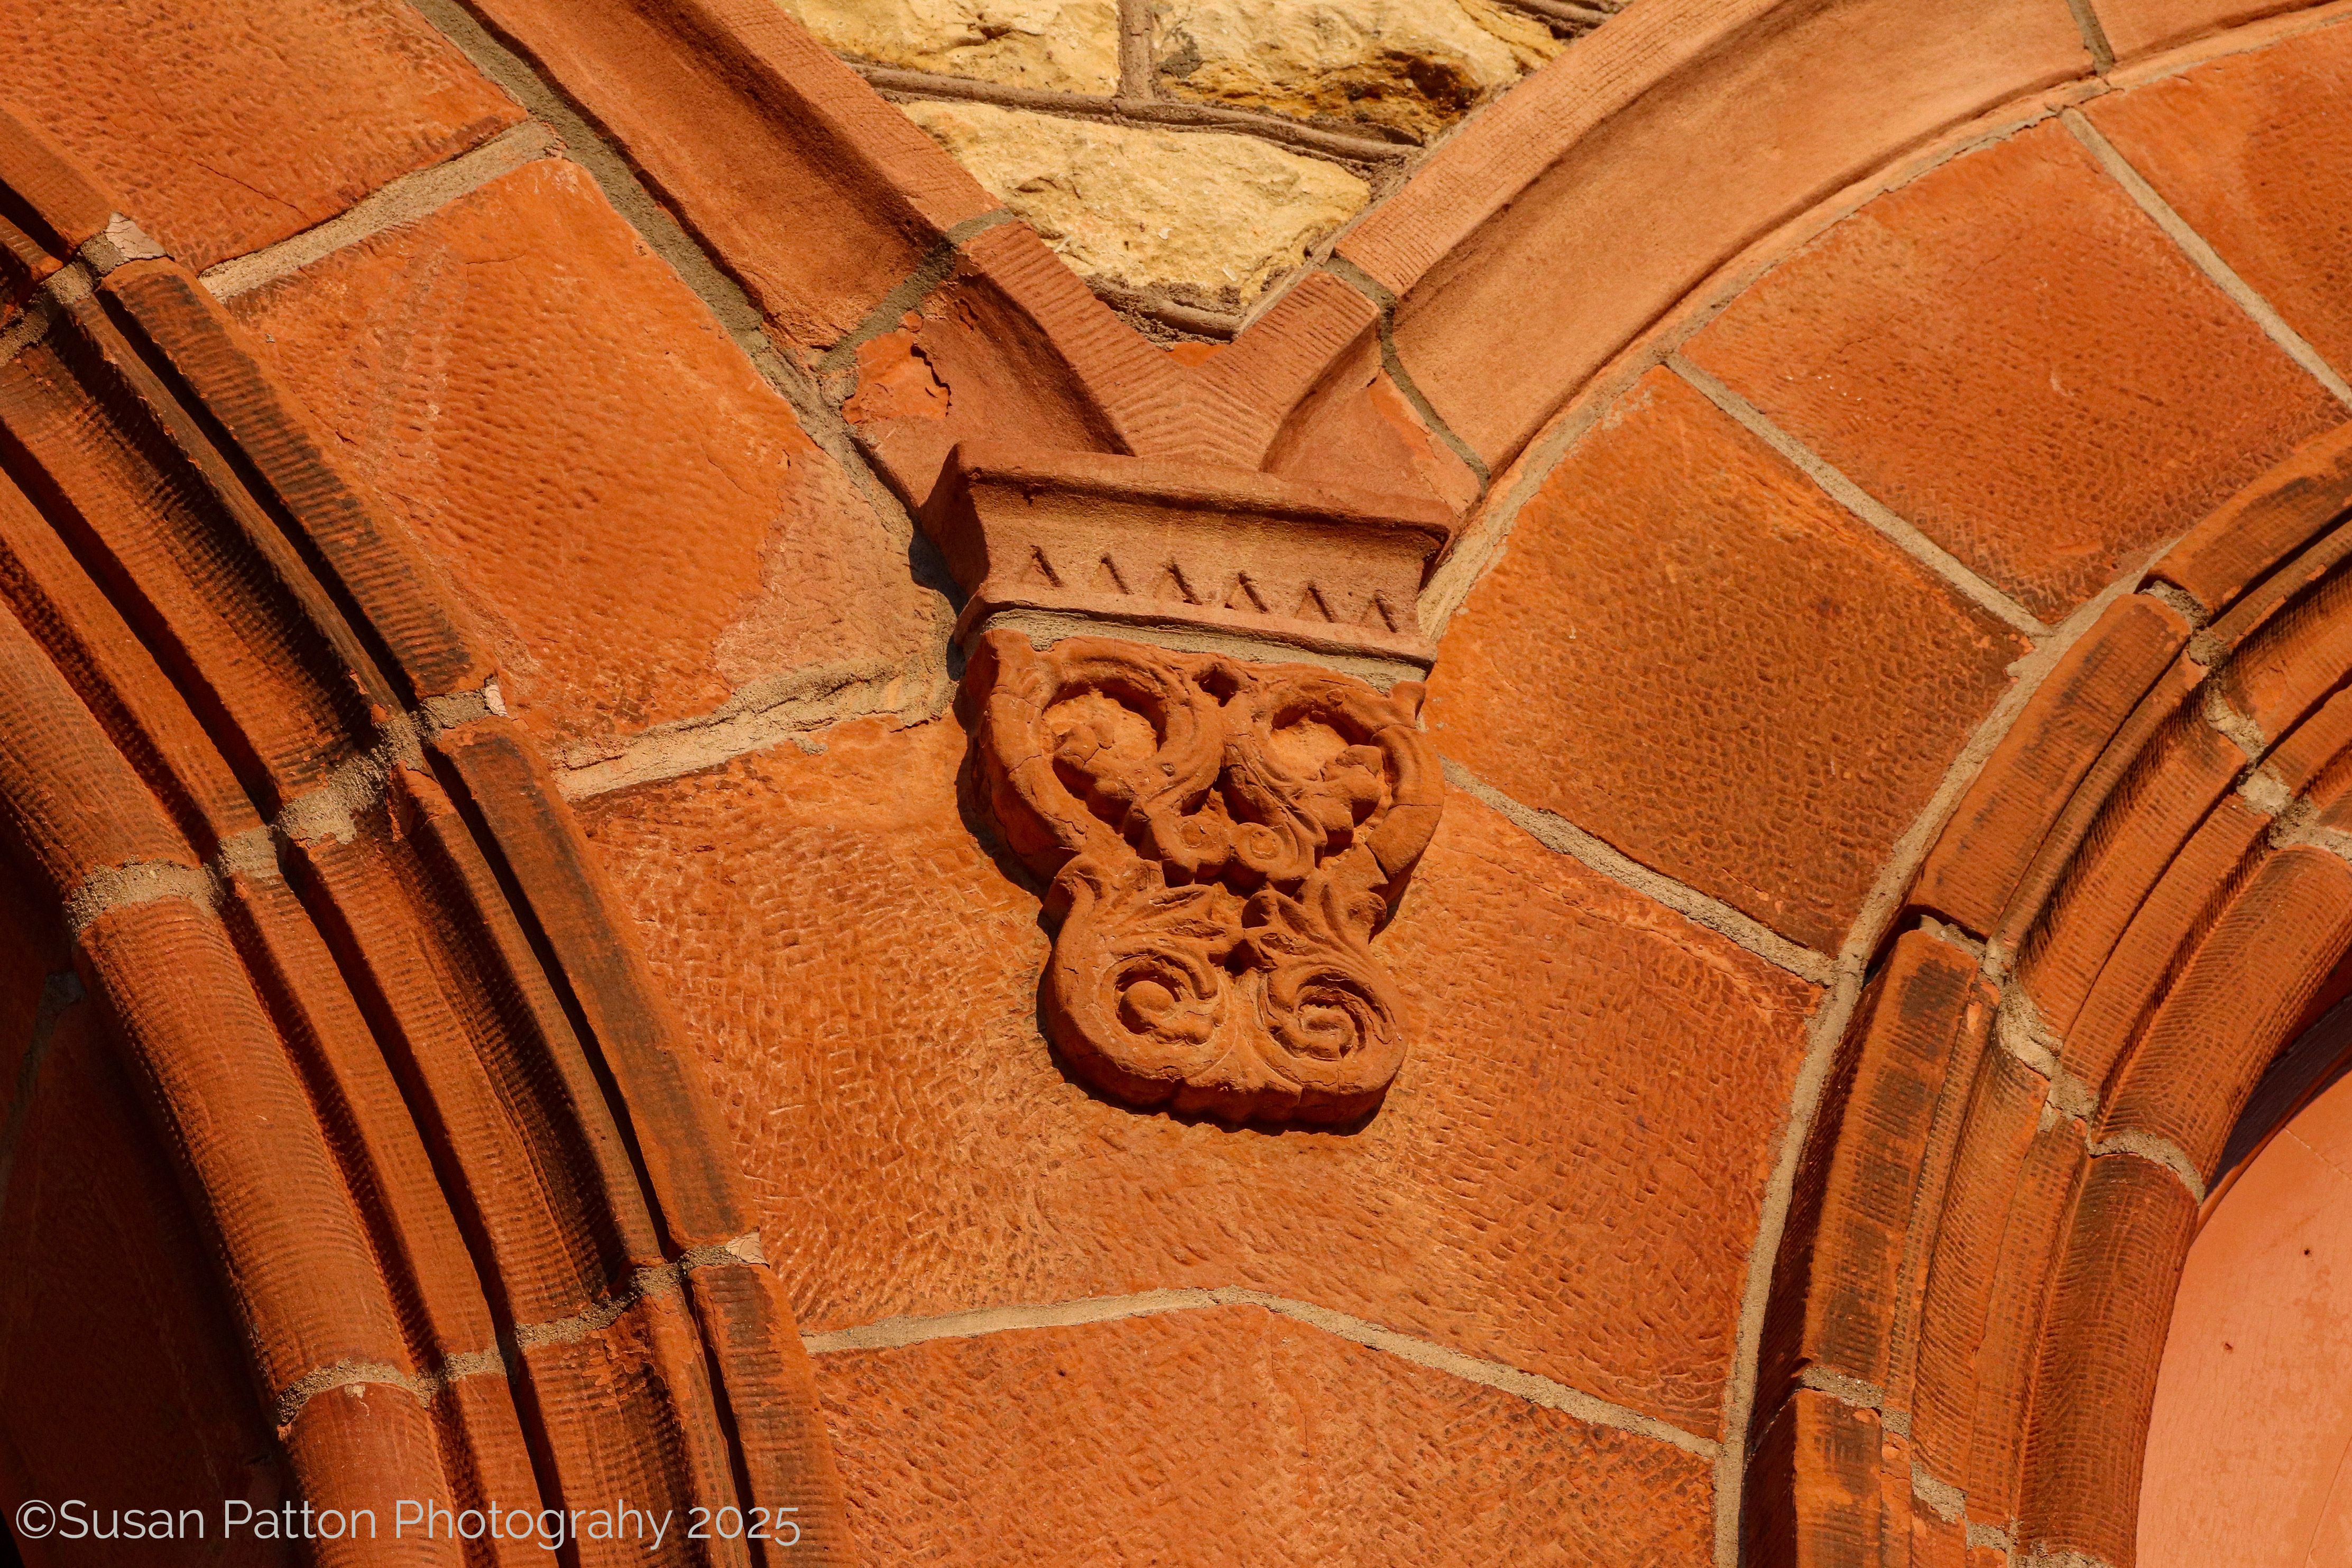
581, 722, 1816, 1434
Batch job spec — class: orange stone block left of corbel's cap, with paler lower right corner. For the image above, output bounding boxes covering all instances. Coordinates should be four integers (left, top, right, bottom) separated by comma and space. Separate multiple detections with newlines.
233, 160, 931, 754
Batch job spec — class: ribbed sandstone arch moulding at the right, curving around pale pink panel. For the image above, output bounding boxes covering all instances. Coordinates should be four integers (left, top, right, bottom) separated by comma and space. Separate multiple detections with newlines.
1748, 430, 2352, 1563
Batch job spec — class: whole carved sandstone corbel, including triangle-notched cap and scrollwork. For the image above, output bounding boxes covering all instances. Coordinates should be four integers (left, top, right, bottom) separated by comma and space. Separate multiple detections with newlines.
924, 447, 1451, 1124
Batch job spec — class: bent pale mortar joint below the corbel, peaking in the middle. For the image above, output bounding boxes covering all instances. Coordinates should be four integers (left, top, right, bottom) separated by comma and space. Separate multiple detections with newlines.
800, 1286, 1722, 1460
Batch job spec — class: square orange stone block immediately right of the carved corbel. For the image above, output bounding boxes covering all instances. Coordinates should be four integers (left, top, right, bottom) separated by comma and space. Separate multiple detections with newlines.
1428, 369, 2027, 952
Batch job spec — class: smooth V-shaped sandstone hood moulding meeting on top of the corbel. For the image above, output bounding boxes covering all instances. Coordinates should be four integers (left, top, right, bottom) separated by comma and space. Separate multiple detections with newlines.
404, 0, 2333, 510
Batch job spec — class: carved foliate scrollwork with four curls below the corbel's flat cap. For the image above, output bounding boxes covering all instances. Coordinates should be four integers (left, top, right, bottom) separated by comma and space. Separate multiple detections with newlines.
967, 630, 1442, 1121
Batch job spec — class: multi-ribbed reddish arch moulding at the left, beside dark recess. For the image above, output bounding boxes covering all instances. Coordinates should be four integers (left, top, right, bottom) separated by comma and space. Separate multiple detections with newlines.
0, 117, 847, 1561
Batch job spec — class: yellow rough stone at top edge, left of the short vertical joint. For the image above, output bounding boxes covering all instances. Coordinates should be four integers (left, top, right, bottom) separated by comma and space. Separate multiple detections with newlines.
779, 0, 1120, 94
